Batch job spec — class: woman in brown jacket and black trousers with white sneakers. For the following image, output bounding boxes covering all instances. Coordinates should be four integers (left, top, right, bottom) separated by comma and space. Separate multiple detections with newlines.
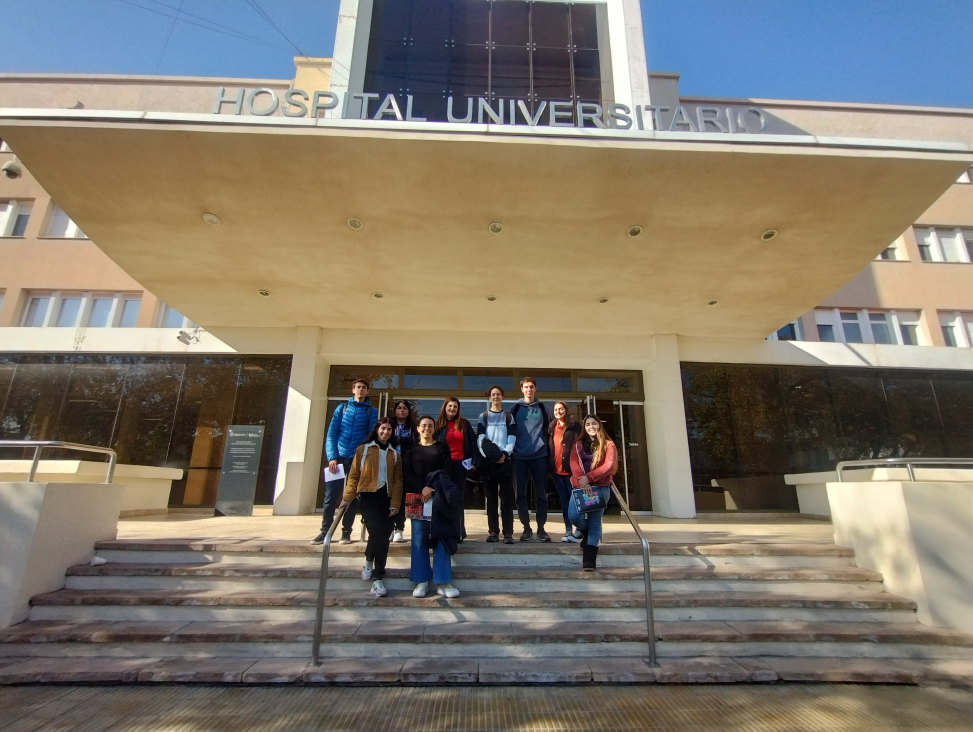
341, 417, 402, 597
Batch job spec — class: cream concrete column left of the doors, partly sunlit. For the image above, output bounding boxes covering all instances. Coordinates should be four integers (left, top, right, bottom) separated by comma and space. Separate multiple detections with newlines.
274, 326, 329, 516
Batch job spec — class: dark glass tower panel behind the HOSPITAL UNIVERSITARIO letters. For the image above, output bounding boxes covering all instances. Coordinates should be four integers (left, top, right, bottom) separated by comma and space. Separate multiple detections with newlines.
364, 0, 602, 125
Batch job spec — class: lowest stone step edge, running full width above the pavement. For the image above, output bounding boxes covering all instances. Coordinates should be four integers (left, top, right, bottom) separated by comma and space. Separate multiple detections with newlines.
0, 657, 973, 688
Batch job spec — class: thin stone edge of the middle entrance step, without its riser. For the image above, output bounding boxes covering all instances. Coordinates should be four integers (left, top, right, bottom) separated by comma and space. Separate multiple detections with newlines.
30, 590, 917, 611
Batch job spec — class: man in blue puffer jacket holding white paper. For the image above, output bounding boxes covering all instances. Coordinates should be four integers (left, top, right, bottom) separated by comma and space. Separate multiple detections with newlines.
311, 379, 378, 544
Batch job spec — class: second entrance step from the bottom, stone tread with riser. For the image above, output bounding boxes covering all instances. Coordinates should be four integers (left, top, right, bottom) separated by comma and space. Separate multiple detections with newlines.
0, 621, 973, 660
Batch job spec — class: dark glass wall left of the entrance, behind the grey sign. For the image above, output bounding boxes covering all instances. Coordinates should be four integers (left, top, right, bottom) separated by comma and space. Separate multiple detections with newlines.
0, 355, 291, 506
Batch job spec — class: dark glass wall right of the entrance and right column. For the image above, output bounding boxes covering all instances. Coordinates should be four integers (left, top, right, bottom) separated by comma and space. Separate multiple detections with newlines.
682, 363, 973, 510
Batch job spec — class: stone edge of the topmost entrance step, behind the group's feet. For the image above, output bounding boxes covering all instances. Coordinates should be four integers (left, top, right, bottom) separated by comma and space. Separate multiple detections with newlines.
95, 539, 855, 557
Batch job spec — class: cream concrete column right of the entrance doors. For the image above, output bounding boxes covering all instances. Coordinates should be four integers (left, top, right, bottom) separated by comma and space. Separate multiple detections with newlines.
642, 335, 696, 518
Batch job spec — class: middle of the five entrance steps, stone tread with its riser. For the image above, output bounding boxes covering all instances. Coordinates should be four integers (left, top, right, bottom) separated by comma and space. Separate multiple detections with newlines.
24, 583, 916, 623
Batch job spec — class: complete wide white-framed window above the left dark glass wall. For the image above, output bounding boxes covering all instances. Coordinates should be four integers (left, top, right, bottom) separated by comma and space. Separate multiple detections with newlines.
20, 291, 142, 328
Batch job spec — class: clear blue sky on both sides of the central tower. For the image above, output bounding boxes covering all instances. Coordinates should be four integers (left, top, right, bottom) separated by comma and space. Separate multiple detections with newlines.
0, 0, 973, 107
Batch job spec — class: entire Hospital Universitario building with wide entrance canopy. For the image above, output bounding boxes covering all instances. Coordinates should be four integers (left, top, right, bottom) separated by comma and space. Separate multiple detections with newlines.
0, 0, 973, 517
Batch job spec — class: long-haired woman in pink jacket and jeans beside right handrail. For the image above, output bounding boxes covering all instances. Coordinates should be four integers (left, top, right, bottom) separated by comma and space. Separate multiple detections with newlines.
568, 414, 618, 572
